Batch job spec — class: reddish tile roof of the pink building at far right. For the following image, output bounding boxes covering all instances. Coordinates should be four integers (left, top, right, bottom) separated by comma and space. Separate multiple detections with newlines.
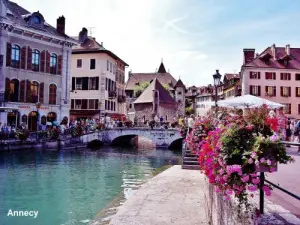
243, 47, 300, 69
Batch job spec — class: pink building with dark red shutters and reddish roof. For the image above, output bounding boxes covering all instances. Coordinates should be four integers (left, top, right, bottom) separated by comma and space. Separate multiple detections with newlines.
241, 44, 300, 118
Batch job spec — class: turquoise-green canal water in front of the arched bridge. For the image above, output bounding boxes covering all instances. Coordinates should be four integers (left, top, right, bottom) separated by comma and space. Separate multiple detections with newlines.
0, 148, 180, 225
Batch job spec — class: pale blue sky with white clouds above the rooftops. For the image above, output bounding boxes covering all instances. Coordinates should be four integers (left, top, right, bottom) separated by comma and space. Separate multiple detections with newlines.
14, 0, 300, 86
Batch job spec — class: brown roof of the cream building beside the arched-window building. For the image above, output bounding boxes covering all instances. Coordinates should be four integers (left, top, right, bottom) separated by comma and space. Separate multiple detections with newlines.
72, 37, 128, 66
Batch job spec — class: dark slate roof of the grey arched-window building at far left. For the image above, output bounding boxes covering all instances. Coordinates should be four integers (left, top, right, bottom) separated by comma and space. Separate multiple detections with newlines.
6, 1, 75, 42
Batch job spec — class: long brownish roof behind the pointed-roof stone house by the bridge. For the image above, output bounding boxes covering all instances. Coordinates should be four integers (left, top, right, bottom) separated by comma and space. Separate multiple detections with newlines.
125, 73, 177, 90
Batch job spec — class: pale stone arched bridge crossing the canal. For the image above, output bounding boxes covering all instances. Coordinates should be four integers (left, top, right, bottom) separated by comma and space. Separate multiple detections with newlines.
81, 128, 183, 148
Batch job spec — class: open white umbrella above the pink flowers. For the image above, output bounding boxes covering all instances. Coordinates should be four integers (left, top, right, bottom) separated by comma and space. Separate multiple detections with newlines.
218, 95, 284, 109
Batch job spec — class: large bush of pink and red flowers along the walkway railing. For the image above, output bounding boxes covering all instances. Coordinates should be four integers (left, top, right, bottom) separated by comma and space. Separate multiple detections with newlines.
186, 106, 293, 211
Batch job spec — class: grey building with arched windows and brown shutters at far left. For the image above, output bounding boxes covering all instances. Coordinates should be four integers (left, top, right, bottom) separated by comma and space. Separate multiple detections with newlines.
0, 0, 76, 130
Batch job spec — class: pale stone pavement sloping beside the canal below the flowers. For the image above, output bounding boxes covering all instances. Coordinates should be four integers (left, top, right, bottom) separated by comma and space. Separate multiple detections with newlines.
110, 165, 208, 225
